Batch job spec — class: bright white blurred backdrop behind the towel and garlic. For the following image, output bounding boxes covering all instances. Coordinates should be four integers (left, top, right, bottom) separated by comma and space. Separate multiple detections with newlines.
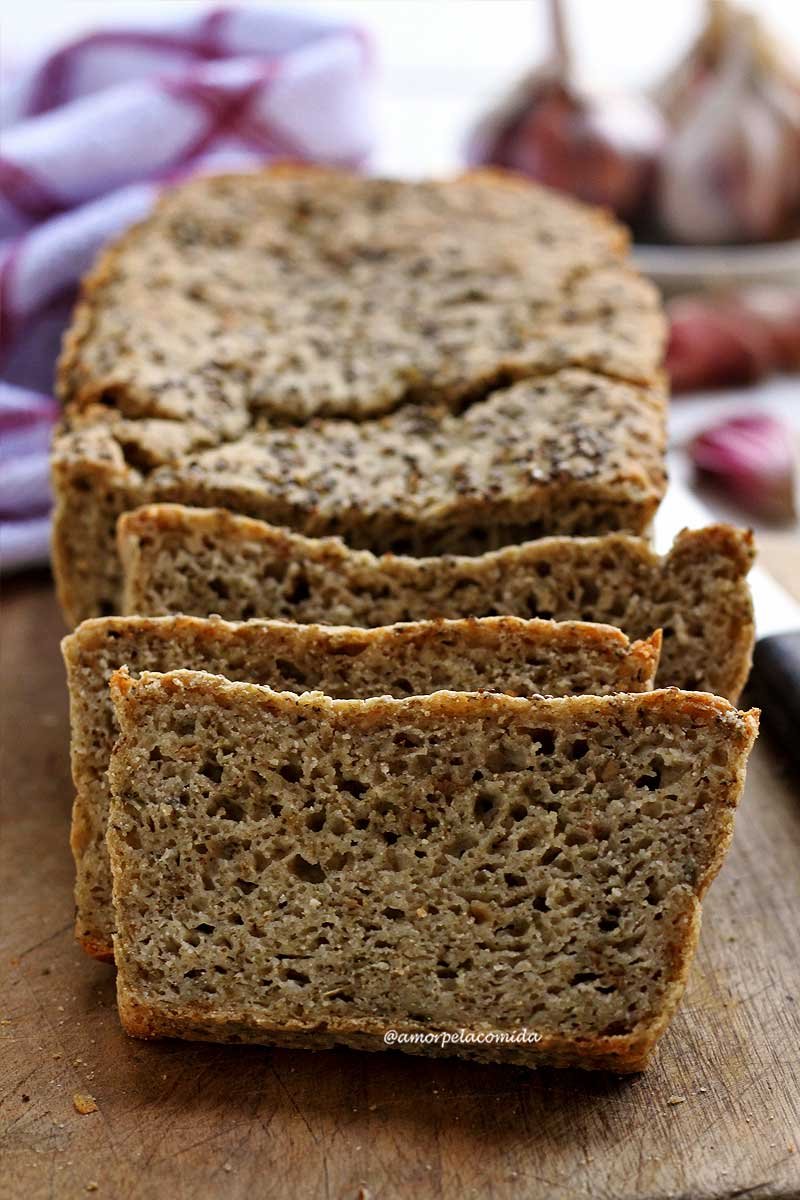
2, 0, 800, 175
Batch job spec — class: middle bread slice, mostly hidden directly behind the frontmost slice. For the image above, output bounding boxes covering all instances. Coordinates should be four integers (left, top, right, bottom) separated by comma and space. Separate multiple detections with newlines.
61, 617, 661, 959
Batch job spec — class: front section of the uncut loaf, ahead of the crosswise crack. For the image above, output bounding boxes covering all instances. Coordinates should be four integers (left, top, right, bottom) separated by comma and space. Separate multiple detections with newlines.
53, 370, 664, 620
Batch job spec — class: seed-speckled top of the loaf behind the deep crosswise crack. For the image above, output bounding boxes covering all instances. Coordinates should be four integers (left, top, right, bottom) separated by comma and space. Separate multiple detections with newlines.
59, 166, 664, 429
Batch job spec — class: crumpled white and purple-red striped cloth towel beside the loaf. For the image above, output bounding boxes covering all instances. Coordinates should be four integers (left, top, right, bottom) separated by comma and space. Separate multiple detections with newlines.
0, 6, 371, 569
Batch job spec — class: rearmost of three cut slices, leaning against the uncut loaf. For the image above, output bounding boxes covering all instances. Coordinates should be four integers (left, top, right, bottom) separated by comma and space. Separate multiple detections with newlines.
119, 505, 754, 703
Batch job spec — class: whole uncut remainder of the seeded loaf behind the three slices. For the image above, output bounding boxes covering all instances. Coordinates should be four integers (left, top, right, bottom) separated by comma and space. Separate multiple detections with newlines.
53, 168, 664, 624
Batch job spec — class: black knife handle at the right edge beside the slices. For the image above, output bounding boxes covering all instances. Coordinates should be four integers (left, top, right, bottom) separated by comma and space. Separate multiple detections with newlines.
748, 630, 800, 763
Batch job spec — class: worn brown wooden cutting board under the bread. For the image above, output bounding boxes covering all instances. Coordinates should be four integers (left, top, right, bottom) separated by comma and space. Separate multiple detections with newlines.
0, 576, 800, 1200
